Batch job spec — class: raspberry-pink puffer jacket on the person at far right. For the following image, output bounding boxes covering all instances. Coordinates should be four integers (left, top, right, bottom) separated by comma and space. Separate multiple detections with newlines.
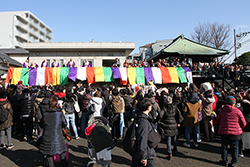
218, 104, 247, 135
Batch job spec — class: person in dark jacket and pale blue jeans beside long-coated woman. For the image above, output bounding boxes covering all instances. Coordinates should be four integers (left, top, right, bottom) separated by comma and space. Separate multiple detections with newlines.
62, 90, 79, 139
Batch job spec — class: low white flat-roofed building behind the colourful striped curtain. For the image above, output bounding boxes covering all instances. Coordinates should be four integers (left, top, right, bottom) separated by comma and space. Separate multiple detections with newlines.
10, 41, 135, 67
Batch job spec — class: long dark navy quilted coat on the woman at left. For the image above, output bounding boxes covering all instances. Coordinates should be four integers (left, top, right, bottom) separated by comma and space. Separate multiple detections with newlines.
39, 109, 67, 155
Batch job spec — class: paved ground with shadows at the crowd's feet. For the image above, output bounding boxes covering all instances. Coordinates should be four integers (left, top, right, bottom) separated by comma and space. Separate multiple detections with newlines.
0, 134, 250, 167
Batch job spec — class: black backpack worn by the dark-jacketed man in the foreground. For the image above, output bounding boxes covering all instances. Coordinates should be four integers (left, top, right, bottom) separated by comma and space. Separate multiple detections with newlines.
122, 118, 138, 155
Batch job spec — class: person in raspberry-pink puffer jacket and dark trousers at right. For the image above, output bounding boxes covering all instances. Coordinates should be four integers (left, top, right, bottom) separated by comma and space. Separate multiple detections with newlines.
218, 96, 247, 166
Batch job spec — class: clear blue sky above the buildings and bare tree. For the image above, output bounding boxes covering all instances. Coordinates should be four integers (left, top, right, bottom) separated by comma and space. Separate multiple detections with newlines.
0, 0, 250, 53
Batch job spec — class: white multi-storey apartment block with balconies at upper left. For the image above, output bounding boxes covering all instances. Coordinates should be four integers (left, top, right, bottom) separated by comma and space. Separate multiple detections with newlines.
0, 11, 53, 48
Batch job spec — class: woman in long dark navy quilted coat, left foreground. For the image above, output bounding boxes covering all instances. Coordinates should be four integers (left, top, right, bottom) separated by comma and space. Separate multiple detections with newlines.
39, 97, 68, 167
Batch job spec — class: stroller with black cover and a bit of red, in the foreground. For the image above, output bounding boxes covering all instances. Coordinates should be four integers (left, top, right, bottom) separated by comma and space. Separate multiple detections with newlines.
85, 116, 114, 167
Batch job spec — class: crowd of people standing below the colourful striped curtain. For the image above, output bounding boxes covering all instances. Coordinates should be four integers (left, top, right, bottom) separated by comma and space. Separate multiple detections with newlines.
0, 82, 250, 166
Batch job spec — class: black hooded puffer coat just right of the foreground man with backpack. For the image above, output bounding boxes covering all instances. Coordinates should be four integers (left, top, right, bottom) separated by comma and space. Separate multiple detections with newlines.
158, 104, 183, 137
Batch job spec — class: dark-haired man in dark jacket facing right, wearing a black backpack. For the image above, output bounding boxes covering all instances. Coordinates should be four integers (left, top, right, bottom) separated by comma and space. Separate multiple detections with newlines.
131, 98, 156, 167
